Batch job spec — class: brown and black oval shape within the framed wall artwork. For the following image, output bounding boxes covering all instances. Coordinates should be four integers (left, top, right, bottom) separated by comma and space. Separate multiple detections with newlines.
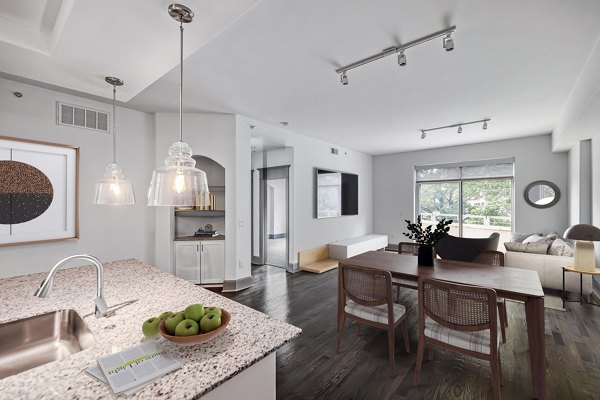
0, 160, 54, 225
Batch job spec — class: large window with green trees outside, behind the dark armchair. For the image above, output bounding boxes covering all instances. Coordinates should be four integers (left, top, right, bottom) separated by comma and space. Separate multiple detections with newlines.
415, 159, 514, 244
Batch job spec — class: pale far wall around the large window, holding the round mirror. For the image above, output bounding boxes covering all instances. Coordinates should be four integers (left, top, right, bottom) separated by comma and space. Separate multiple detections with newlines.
373, 135, 568, 242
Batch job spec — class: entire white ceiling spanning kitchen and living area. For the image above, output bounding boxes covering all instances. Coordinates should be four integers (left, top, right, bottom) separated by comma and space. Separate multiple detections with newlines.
0, 0, 600, 155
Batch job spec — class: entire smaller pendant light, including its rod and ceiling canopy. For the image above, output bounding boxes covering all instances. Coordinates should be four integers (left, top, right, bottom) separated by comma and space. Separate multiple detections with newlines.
94, 76, 135, 206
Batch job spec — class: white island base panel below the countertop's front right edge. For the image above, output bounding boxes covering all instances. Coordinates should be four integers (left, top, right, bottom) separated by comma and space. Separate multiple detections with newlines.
202, 353, 276, 400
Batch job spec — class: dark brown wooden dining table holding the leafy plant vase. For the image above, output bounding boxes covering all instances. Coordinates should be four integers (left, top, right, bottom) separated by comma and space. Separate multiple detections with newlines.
338, 251, 546, 399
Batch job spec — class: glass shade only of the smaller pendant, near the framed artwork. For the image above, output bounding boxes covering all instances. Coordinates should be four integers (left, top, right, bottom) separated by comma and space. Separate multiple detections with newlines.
94, 163, 135, 206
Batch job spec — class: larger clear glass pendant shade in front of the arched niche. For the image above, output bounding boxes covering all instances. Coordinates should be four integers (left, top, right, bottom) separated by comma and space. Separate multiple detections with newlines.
148, 142, 210, 208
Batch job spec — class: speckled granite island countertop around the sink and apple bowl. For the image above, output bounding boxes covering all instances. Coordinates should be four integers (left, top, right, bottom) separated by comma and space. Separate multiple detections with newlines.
0, 259, 301, 400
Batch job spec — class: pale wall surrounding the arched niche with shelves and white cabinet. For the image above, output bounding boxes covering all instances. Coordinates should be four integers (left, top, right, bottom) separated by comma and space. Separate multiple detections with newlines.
155, 113, 251, 281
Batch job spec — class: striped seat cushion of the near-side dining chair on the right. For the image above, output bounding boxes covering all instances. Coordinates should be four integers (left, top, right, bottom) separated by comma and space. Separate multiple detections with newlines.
425, 317, 500, 354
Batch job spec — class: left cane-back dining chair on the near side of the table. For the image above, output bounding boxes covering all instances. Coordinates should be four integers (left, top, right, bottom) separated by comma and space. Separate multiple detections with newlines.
336, 264, 410, 376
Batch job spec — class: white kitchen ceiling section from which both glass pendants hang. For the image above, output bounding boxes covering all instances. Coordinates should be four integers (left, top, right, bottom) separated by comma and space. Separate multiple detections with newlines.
0, 0, 259, 102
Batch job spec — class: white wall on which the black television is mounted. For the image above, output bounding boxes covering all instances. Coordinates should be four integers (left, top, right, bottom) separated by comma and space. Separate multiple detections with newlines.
239, 117, 372, 264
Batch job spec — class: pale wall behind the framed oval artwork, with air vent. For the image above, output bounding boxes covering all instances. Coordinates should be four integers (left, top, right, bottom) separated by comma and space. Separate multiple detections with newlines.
0, 79, 154, 277
